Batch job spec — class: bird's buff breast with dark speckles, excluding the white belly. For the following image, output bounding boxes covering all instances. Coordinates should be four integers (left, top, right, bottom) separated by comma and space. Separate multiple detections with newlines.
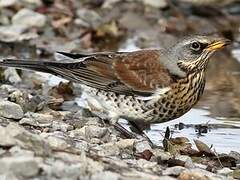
145, 70, 205, 123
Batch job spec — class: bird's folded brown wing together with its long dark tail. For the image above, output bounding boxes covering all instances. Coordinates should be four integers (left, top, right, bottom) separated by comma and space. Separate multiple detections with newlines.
0, 50, 173, 95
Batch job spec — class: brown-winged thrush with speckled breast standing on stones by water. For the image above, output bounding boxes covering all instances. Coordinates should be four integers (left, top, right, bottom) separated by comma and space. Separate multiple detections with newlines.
0, 35, 230, 141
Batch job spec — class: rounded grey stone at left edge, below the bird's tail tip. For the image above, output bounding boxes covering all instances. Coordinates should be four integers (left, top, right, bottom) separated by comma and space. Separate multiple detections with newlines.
0, 100, 23, 119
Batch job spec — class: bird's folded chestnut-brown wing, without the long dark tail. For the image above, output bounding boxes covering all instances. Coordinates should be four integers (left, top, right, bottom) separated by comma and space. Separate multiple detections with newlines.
55, 50, 173, 95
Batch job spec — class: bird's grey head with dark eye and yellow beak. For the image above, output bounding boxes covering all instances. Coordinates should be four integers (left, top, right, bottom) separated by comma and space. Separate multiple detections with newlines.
170, 36, 230, 72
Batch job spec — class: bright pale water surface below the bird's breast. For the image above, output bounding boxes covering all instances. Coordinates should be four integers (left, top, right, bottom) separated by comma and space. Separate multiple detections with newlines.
147, 109, 240, 152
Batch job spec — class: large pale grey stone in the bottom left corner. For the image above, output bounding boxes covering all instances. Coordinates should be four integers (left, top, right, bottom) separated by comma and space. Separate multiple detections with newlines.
0, 157, 39, 178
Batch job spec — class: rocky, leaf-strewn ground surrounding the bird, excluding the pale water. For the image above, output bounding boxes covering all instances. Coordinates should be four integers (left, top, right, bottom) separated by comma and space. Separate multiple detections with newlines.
0, 0, 240, 180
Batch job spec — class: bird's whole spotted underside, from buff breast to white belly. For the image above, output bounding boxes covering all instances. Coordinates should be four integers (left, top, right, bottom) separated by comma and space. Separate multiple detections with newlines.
83, 70, 205, 123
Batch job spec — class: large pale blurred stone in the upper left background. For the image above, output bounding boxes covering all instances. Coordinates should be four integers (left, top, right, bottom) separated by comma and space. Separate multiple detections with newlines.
12, 8, 47, 28
